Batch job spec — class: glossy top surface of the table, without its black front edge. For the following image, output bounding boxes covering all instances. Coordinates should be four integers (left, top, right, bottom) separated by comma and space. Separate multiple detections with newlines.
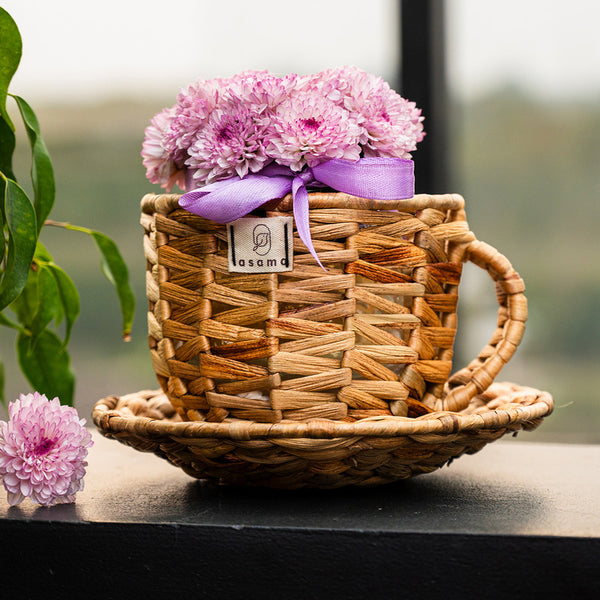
0, 432, 600, 537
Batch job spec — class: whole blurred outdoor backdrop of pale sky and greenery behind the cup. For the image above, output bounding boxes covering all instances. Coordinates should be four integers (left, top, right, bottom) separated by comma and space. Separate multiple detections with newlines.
0, 0, 600, 443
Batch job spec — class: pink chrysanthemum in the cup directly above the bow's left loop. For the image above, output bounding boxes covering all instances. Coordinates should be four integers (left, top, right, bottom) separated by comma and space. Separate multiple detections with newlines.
186, 91, 270, 185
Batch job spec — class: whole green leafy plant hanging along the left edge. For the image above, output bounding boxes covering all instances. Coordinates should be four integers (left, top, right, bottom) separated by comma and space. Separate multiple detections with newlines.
0, 8, 135, 404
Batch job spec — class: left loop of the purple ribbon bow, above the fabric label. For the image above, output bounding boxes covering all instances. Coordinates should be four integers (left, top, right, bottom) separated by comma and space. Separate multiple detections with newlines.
179, 175, 292, 223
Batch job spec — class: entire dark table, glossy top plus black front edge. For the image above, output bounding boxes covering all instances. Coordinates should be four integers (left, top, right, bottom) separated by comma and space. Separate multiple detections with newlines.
0, 433, 600, 600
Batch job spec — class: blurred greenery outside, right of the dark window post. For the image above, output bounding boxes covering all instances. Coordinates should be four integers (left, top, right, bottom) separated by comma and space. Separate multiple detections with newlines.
451, 88, 600, 443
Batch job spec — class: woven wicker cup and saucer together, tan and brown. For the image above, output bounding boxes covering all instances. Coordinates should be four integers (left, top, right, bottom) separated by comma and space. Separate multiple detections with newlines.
93, 193, 553, 488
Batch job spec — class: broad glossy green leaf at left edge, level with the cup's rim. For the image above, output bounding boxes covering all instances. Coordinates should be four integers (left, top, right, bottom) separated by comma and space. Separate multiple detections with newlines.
0, 179, 37, 310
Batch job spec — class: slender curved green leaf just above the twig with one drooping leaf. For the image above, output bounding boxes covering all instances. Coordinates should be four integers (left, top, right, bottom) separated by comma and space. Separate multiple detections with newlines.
12, 95, 56, 235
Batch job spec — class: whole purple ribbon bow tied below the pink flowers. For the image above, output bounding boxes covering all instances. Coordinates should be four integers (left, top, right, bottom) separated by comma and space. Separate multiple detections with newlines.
179, 157, 415, 268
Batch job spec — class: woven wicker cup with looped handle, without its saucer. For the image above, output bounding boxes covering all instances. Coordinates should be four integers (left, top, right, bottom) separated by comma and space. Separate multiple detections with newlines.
141, 193, 527, 424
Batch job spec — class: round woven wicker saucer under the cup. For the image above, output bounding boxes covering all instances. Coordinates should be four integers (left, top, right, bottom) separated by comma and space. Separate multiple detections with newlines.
93, 383, 553, 488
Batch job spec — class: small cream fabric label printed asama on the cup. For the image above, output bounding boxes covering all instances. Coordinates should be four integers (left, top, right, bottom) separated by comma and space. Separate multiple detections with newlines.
227, 217, 294, 273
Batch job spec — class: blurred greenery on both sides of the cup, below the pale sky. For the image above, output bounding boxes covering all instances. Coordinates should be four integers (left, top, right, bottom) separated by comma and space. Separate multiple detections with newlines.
0, 89, 600, 443
